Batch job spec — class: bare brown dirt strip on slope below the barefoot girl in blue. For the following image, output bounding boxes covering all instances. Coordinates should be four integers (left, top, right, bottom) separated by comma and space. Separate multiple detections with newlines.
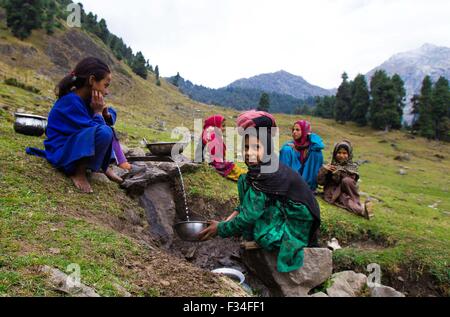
51, 198, 245, 296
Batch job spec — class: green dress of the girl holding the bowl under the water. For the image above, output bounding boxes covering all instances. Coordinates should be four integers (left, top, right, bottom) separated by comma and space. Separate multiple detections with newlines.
218, 175, 314, 272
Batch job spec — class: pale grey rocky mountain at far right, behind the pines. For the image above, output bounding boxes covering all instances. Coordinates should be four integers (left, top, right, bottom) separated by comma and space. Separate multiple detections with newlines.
366, 44, 450, 123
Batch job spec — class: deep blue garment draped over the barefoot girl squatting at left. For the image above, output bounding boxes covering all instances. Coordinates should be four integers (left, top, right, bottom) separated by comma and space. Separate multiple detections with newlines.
26, 93, 117, 170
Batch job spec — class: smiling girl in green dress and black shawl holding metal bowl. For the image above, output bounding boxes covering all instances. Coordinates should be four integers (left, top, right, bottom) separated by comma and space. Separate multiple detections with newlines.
200, 113, 320, 272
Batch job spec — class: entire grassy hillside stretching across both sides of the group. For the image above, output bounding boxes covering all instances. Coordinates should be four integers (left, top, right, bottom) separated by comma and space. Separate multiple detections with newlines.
0, 13, 450, 296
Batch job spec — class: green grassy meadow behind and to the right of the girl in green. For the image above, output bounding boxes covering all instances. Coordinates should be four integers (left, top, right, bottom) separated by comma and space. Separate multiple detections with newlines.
187, 115, 450, 295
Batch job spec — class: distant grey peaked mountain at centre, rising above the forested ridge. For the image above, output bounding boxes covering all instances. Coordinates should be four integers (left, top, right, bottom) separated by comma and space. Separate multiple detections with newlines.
228, 70, 332, 99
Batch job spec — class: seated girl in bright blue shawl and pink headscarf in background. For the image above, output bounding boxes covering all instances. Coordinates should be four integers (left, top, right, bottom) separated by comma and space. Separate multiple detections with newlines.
280, 120, 325, 191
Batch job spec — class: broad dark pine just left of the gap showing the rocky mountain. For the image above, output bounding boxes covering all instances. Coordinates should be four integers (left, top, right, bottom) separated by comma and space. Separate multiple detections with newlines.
369, 70, 401, 131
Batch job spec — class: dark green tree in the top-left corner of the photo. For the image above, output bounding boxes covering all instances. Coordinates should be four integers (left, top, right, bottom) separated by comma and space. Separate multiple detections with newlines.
6, 0, 44, 40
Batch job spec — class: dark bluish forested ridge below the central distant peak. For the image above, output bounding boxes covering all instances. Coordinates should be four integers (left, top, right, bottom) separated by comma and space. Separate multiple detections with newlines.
167, 77, 314, 113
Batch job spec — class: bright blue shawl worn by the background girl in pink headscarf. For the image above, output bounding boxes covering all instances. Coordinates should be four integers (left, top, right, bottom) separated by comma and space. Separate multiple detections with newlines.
280, 133, 325, 190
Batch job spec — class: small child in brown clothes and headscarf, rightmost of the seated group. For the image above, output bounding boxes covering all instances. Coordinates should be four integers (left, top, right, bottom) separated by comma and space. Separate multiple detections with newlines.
317, 140, 372, 220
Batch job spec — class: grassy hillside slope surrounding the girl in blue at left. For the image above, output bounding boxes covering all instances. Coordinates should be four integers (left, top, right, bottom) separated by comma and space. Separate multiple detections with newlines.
0, 12, 245, 296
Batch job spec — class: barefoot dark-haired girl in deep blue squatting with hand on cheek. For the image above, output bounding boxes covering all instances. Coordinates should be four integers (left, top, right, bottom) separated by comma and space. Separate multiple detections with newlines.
27, 57, 122, 193
